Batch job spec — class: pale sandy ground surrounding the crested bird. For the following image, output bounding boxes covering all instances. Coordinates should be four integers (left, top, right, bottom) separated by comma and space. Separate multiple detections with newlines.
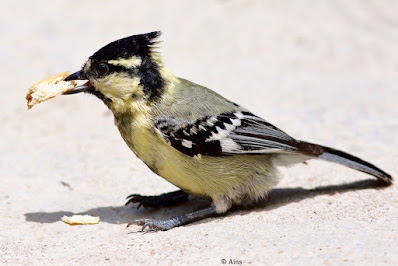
0, 0, 398, 265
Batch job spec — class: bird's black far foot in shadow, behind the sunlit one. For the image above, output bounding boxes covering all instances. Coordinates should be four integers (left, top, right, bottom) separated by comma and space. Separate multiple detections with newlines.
126, 190, 188, 209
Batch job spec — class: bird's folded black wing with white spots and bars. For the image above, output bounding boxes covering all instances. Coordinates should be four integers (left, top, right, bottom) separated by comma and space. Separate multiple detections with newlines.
155, 107, 314, 157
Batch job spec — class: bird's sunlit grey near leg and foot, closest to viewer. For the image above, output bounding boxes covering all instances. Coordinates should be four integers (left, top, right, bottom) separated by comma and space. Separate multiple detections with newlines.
127, 206, 216, 231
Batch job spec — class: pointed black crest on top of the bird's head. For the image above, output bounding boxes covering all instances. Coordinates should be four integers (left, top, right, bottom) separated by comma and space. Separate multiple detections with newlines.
90, 31, 161, 61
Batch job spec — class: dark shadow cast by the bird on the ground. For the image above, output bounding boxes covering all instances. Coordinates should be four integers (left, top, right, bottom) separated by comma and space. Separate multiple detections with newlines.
25, 179, 387, 224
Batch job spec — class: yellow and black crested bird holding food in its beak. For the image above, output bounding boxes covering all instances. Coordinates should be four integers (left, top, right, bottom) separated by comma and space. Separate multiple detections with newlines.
65, 31, 393, 231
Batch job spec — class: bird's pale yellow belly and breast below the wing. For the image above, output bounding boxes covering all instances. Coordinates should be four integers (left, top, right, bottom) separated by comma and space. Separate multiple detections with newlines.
121, 120, 278, 210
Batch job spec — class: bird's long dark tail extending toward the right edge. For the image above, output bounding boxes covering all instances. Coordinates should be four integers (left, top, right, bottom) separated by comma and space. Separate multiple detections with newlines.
300, 141, 392, 184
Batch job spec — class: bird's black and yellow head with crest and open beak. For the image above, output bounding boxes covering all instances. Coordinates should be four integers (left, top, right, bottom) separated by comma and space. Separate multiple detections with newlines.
66, 31, 174, 113
